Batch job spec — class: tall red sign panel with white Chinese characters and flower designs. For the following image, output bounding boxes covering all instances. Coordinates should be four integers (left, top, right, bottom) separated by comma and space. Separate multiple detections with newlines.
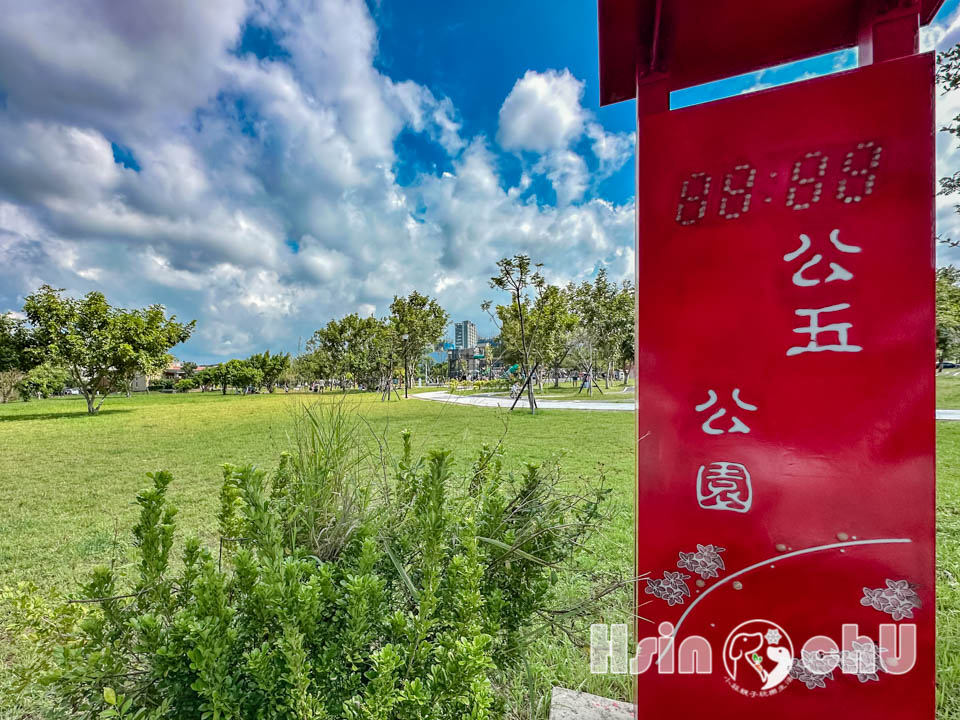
636, 55, 936, 720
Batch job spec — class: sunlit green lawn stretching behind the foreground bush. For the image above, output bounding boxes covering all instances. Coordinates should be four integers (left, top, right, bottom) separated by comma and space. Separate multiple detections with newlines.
0, 377, 960, 718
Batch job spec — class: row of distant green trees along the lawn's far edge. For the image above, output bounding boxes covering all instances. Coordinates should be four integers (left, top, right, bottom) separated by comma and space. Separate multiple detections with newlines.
0, 262, 634, 414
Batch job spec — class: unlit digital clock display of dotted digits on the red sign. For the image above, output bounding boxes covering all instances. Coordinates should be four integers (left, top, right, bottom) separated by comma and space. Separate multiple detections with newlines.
676, 140, 883, 226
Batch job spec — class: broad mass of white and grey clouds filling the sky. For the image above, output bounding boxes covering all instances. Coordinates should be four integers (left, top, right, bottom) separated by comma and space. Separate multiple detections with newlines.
0, 0, 633, 360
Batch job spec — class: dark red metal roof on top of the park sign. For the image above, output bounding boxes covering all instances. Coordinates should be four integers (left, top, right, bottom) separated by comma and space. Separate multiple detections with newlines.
597, 0, 943, 105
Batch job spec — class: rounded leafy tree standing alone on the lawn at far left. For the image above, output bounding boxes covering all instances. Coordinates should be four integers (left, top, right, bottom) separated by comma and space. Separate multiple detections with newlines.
23, 285, 196, 415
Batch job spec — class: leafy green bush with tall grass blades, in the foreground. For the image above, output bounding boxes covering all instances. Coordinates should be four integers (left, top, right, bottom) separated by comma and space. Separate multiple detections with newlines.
5, 402, 606, 720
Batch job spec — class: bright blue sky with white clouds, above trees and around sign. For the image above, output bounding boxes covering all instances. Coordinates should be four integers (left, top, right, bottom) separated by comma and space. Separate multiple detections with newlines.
0, 0, 960, 362
